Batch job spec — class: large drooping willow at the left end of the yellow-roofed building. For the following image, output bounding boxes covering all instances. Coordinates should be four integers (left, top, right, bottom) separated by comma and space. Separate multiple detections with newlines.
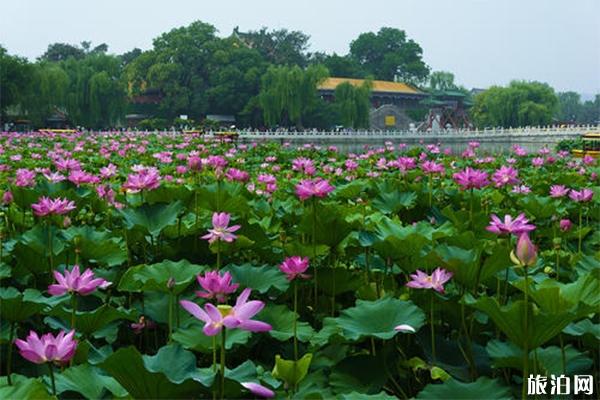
259, 65, 328, 127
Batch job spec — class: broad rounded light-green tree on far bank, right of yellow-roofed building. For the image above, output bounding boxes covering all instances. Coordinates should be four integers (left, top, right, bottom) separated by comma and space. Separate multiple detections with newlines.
471, 81, 558, 127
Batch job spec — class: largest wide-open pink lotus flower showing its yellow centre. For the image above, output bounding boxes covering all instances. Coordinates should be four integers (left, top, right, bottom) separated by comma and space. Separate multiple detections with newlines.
179, 288, 273, 336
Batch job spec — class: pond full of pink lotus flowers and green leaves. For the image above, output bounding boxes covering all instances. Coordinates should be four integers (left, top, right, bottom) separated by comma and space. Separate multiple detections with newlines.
0, 132, 600, 399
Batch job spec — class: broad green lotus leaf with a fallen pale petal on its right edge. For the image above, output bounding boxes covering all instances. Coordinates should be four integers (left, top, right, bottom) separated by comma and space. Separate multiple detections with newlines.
336, 297, 425, 340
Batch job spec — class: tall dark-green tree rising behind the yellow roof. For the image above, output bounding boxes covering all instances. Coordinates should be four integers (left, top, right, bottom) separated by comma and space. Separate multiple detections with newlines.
350, 27, 429, 83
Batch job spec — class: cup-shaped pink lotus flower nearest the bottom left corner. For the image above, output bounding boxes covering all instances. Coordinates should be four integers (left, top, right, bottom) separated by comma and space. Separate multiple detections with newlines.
15, 330, 77, 364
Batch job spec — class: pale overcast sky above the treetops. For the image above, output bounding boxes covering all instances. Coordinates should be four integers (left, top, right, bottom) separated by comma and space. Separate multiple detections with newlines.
0, 0, 600, 94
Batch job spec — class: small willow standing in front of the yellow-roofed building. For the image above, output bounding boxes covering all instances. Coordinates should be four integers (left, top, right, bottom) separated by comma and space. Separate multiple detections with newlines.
335, 80, 373, 128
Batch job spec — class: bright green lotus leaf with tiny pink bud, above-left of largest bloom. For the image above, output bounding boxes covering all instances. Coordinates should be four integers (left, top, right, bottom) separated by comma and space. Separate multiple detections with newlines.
119, 260, 207, 294
